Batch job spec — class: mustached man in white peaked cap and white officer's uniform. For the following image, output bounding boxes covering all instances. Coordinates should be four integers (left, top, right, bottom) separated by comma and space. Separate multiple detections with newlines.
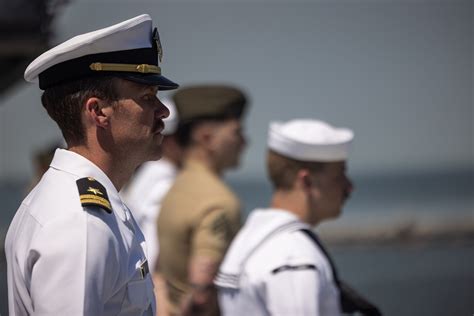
5, 14, 178, 315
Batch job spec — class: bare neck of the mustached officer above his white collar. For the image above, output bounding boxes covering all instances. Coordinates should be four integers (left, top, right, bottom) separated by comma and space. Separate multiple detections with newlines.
69, 145, 138, 191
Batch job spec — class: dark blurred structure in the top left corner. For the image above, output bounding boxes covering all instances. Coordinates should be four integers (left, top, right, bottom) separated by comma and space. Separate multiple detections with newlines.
0, 0, 70, 95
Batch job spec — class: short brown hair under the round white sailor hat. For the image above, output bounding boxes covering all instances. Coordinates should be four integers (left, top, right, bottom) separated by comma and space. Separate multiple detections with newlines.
267, 149, 326, 190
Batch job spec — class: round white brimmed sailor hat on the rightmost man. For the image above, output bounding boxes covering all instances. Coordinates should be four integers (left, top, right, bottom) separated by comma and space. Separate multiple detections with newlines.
267, 119, 354, 162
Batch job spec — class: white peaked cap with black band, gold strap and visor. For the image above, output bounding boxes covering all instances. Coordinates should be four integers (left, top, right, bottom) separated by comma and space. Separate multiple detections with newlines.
24, 14, 178, 90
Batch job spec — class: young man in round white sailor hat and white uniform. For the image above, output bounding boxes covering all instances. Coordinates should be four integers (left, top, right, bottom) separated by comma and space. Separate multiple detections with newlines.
215, 119, 378, 316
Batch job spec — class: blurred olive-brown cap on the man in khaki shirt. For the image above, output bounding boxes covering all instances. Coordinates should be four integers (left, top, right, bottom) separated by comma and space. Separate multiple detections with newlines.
173, 85, 247, 123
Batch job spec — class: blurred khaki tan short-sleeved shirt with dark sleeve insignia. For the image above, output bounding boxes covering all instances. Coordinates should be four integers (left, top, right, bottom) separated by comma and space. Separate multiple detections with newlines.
158, 160, 240, 314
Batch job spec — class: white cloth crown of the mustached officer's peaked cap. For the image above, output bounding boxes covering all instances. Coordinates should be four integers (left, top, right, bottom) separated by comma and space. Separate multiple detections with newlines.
25, 14, 152, 82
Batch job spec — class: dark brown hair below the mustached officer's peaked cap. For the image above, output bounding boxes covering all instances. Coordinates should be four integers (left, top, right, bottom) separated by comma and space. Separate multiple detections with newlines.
41, 76, 119, 146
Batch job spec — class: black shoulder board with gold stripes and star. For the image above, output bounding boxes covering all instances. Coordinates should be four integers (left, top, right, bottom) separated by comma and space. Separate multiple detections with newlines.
76, 177, 112, 213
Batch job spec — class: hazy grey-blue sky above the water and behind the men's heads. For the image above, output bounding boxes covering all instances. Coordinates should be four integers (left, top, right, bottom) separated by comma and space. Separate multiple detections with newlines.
0, 0, 474, 179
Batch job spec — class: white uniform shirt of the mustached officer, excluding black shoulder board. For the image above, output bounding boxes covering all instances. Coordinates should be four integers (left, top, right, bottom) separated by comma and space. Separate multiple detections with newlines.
5, 149, 156, 316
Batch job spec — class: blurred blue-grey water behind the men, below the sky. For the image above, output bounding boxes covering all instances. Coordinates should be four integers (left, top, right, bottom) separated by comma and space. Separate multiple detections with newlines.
0, 170, 474, 316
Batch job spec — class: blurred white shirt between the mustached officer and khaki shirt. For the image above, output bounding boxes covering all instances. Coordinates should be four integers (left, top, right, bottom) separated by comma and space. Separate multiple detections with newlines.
120, 158, 178, 269
